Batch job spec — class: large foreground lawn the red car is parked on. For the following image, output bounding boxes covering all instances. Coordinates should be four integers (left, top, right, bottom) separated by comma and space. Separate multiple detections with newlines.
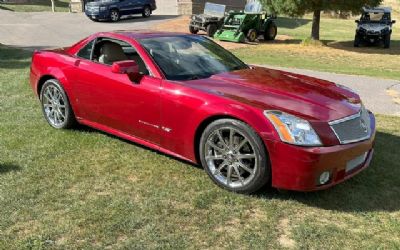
0, 47, 400, 249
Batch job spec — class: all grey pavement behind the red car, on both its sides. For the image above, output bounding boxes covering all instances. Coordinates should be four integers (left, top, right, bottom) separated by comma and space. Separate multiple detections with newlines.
0, 10, 400, 116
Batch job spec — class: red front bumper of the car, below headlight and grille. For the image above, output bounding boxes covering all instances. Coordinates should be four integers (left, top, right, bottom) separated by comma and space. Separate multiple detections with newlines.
264, 114, 376, 191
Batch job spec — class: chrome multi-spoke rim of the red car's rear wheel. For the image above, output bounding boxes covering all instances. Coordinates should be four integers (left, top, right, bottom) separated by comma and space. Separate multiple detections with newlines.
42, 85, 67, 127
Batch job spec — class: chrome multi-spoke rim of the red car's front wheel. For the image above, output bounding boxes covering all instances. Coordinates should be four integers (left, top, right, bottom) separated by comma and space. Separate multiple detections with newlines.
204, 127, 258, 188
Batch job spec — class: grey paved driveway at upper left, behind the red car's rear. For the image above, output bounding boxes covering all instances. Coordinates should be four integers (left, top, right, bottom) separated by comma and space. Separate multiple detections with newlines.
0, 10, 174, 49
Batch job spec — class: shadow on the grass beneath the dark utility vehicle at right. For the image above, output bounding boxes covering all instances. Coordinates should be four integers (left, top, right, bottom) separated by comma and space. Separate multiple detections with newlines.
327, 40, 400, 55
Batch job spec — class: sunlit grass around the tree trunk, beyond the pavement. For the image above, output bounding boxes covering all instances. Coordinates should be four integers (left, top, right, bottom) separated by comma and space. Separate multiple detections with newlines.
234, 0, 400, 80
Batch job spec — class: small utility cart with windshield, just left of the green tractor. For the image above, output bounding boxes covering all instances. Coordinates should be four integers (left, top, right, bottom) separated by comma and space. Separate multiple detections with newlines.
189, 2, 226, 37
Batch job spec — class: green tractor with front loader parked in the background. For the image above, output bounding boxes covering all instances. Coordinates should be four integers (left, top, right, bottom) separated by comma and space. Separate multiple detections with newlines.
214, 1, 278, 42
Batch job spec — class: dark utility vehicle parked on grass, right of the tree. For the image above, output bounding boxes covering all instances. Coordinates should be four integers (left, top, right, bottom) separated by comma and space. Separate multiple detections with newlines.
354, 7, 396, 48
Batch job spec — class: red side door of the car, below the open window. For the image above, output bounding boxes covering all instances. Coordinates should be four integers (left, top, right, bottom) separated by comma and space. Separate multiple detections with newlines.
74, 37, 161, 144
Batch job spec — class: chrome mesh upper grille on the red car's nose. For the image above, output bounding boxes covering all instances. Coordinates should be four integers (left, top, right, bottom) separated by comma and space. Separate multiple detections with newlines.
329, 107, 371, 144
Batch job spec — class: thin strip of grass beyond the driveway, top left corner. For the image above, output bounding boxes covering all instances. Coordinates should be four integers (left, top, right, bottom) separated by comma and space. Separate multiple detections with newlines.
0, 0, 70, 12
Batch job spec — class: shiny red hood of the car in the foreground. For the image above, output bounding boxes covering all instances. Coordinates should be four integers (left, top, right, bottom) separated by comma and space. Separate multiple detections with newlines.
185, 67, 361, 121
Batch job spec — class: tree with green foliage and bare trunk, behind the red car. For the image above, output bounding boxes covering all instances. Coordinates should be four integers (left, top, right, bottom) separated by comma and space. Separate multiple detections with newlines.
262, 0, 383, 40
